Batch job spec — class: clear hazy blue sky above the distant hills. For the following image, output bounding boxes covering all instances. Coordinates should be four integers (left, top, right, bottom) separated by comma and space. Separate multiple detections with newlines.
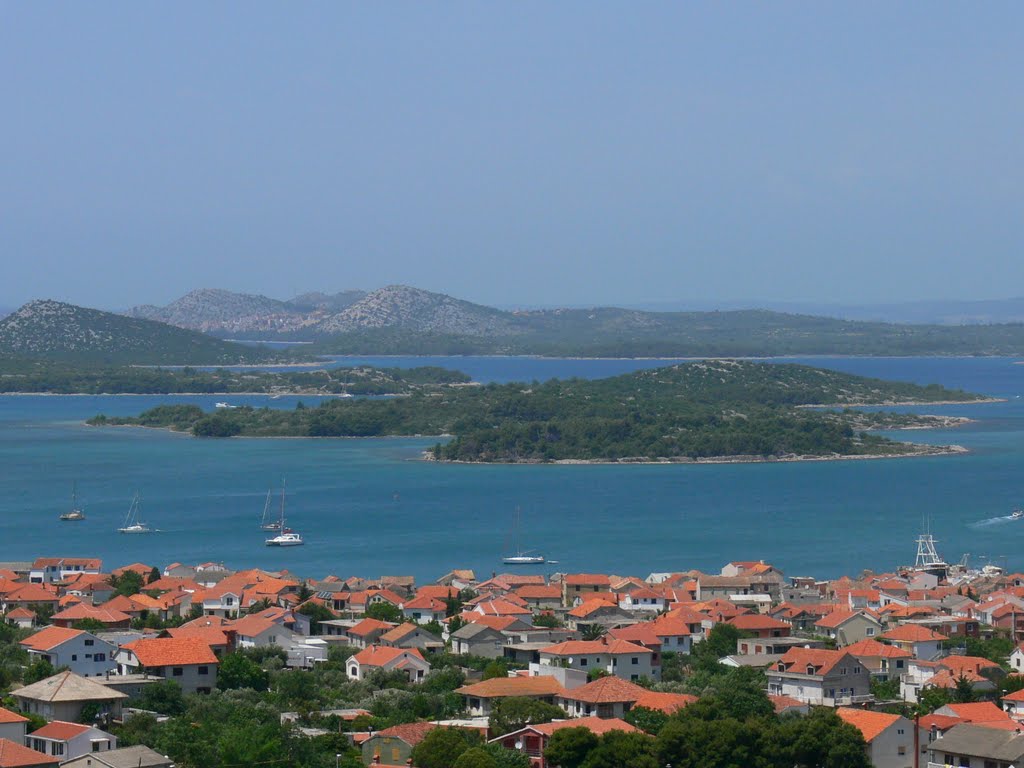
0, 5, 1024, 308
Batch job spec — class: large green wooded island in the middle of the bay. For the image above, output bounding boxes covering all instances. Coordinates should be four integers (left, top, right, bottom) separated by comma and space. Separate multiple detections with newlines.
83, 360, 981, 462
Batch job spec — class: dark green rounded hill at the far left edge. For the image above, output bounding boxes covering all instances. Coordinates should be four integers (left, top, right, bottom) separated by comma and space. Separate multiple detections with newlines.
0, 299, 274, 366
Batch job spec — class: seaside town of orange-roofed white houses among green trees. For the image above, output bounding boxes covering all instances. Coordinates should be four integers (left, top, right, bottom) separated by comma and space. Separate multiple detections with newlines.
0, 536, 1024, 768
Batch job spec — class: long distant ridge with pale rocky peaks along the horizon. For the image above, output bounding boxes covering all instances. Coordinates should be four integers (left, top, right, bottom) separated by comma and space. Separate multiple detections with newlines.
119, 286, 1024, 357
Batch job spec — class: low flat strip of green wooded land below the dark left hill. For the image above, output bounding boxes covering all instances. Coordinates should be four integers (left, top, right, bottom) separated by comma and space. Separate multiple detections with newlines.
0, 359, 470, 395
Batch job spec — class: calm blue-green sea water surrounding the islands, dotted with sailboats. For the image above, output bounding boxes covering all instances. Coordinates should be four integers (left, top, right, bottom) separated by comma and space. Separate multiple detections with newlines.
0, 357, 1024, 580
